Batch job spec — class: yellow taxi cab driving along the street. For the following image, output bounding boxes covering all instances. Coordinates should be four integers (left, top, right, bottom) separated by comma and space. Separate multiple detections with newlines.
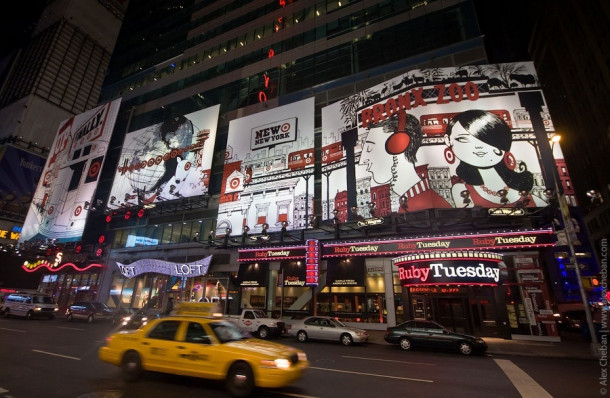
98, 303, 309, 397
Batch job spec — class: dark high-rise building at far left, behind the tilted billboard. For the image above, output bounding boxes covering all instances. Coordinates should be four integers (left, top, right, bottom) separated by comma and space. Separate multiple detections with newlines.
0, 0, 126, 285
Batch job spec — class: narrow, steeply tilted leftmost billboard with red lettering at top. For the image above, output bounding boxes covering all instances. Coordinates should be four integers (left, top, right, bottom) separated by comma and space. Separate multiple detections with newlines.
19, 99, 121, 243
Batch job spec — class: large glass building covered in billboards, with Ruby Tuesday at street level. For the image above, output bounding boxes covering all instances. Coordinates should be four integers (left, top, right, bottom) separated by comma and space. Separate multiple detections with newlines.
4, 0, 600, 341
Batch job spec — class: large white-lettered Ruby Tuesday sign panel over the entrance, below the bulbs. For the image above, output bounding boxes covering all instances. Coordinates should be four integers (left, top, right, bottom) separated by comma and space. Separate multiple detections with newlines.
396, 259, 500, 286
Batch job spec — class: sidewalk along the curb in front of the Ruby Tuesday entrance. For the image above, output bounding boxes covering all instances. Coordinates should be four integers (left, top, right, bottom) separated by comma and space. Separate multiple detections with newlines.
367, 330, 598, 360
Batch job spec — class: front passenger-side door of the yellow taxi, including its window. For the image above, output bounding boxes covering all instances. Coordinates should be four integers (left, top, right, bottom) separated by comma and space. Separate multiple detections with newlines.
176, 320, 220, 377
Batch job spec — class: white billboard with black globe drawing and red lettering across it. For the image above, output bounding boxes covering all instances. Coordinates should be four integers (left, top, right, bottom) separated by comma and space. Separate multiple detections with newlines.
107, 105, 220, 210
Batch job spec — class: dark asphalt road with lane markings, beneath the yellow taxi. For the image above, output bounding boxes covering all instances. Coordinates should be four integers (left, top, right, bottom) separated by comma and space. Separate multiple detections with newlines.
0, 318, 604, 398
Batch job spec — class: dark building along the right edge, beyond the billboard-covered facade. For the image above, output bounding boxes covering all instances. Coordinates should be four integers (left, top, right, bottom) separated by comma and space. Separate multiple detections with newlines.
530, 1, 610, 256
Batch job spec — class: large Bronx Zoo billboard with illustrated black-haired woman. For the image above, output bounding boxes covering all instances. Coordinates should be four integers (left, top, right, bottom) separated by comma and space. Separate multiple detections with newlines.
322, 62, 563, 221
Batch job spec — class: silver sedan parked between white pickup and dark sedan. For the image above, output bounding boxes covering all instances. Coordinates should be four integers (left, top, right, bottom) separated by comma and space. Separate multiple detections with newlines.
286, 316, 369, 345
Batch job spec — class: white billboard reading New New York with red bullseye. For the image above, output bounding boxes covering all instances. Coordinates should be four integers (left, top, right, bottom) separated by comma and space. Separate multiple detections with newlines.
216, 98, 314, 236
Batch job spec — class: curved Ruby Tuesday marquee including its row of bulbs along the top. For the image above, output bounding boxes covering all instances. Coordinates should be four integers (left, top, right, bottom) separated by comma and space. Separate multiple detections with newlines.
393, 251, 502, 286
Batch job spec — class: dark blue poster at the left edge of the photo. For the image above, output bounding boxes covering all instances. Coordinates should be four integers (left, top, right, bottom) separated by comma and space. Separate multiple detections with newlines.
0, 145, 46, 219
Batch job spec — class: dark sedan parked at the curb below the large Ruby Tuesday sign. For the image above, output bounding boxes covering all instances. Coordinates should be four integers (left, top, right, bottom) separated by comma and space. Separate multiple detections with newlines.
384, 320, 487, 355
